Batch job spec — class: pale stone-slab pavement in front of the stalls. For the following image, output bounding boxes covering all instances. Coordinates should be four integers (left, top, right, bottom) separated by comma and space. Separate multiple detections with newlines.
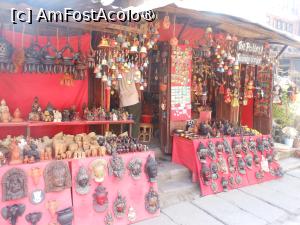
136, 169, 300, 225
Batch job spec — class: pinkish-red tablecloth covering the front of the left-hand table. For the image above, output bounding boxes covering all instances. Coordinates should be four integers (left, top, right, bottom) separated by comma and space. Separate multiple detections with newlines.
0, 151, 160, 225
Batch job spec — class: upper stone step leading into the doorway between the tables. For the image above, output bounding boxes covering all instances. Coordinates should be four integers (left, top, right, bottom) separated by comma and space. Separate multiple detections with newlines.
158, 160, 191, 184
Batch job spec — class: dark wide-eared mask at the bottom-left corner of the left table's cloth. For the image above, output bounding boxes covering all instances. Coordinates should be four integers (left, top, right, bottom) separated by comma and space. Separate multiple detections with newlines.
1, 204, 25, 225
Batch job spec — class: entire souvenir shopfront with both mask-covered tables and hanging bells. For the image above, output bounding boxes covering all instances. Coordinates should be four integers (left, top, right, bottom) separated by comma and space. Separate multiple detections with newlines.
0, 1, 300, 225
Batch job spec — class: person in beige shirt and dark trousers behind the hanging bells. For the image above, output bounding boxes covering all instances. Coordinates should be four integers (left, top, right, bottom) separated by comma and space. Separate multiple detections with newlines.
118, 69, 141, 138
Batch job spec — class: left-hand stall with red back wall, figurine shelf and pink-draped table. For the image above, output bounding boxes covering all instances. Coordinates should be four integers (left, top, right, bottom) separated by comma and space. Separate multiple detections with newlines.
0, 1, 164, 225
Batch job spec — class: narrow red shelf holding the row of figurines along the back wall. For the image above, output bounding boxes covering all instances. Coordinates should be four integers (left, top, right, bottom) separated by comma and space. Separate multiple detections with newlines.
0, 120, 134, 137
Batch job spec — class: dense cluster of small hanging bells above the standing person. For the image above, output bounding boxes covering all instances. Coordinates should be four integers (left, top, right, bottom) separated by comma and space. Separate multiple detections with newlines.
94, 24, 159, 90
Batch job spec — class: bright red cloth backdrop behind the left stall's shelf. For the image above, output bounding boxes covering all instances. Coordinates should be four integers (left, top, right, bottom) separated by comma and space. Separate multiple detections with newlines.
0, 31, 90, 137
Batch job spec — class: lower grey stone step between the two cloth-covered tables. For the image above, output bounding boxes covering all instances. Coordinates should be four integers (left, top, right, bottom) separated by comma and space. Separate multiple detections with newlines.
158, 178, 200, 208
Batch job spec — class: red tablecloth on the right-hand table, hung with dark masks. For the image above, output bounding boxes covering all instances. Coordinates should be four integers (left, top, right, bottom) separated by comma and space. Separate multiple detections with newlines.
172, 135, 279, 195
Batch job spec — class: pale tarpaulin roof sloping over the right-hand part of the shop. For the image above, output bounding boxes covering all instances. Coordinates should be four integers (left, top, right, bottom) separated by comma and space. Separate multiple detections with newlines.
124, 0, 300, 47
